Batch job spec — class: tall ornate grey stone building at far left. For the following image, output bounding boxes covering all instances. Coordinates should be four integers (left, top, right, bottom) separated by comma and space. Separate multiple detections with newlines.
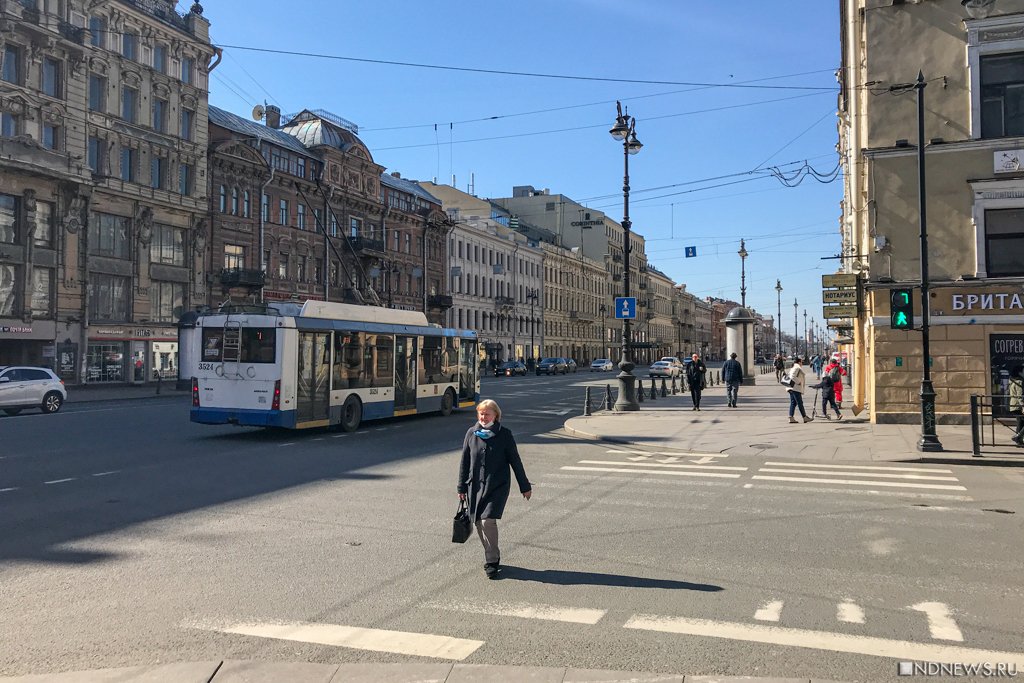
0, 0, 216, 383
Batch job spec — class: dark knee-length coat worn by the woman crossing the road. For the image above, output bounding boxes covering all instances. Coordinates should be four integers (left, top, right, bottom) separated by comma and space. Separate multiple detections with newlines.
459, 423, 532, 519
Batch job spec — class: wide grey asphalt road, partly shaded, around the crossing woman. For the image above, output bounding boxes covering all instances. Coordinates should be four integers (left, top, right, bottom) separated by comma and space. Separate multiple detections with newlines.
0, 373, 1024, 681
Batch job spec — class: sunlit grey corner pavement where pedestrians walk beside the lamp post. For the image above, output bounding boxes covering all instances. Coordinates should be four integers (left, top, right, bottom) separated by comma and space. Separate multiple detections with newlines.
565, 374, 1024, 464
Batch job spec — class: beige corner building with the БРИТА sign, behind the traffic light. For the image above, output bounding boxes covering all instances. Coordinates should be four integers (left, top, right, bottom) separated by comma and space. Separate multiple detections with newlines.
839, 0, 1024, 423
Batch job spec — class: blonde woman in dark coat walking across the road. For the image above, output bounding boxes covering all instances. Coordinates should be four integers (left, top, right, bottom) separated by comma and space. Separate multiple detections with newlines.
458, 399, 532, 579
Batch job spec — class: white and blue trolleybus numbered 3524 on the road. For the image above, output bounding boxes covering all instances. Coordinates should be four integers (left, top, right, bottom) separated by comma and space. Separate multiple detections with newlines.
187, 301, 480, 431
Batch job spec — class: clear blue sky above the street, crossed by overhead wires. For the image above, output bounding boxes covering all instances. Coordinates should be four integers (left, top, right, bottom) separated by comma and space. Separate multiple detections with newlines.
195, 0, 843, 342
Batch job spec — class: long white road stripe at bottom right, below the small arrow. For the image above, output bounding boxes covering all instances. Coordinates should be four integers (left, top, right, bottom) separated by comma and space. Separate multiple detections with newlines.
624, 614, 1024, 668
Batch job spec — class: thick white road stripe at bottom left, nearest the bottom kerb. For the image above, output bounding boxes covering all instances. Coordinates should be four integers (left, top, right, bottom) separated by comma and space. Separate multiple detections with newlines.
215, 623, 484, 660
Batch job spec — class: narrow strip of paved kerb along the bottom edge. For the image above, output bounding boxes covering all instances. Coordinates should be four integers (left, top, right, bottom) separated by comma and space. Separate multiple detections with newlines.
0, 659, 847, 683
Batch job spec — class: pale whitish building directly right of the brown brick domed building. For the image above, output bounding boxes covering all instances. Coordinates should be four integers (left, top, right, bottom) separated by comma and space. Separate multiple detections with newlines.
419, 181, 547, 367
